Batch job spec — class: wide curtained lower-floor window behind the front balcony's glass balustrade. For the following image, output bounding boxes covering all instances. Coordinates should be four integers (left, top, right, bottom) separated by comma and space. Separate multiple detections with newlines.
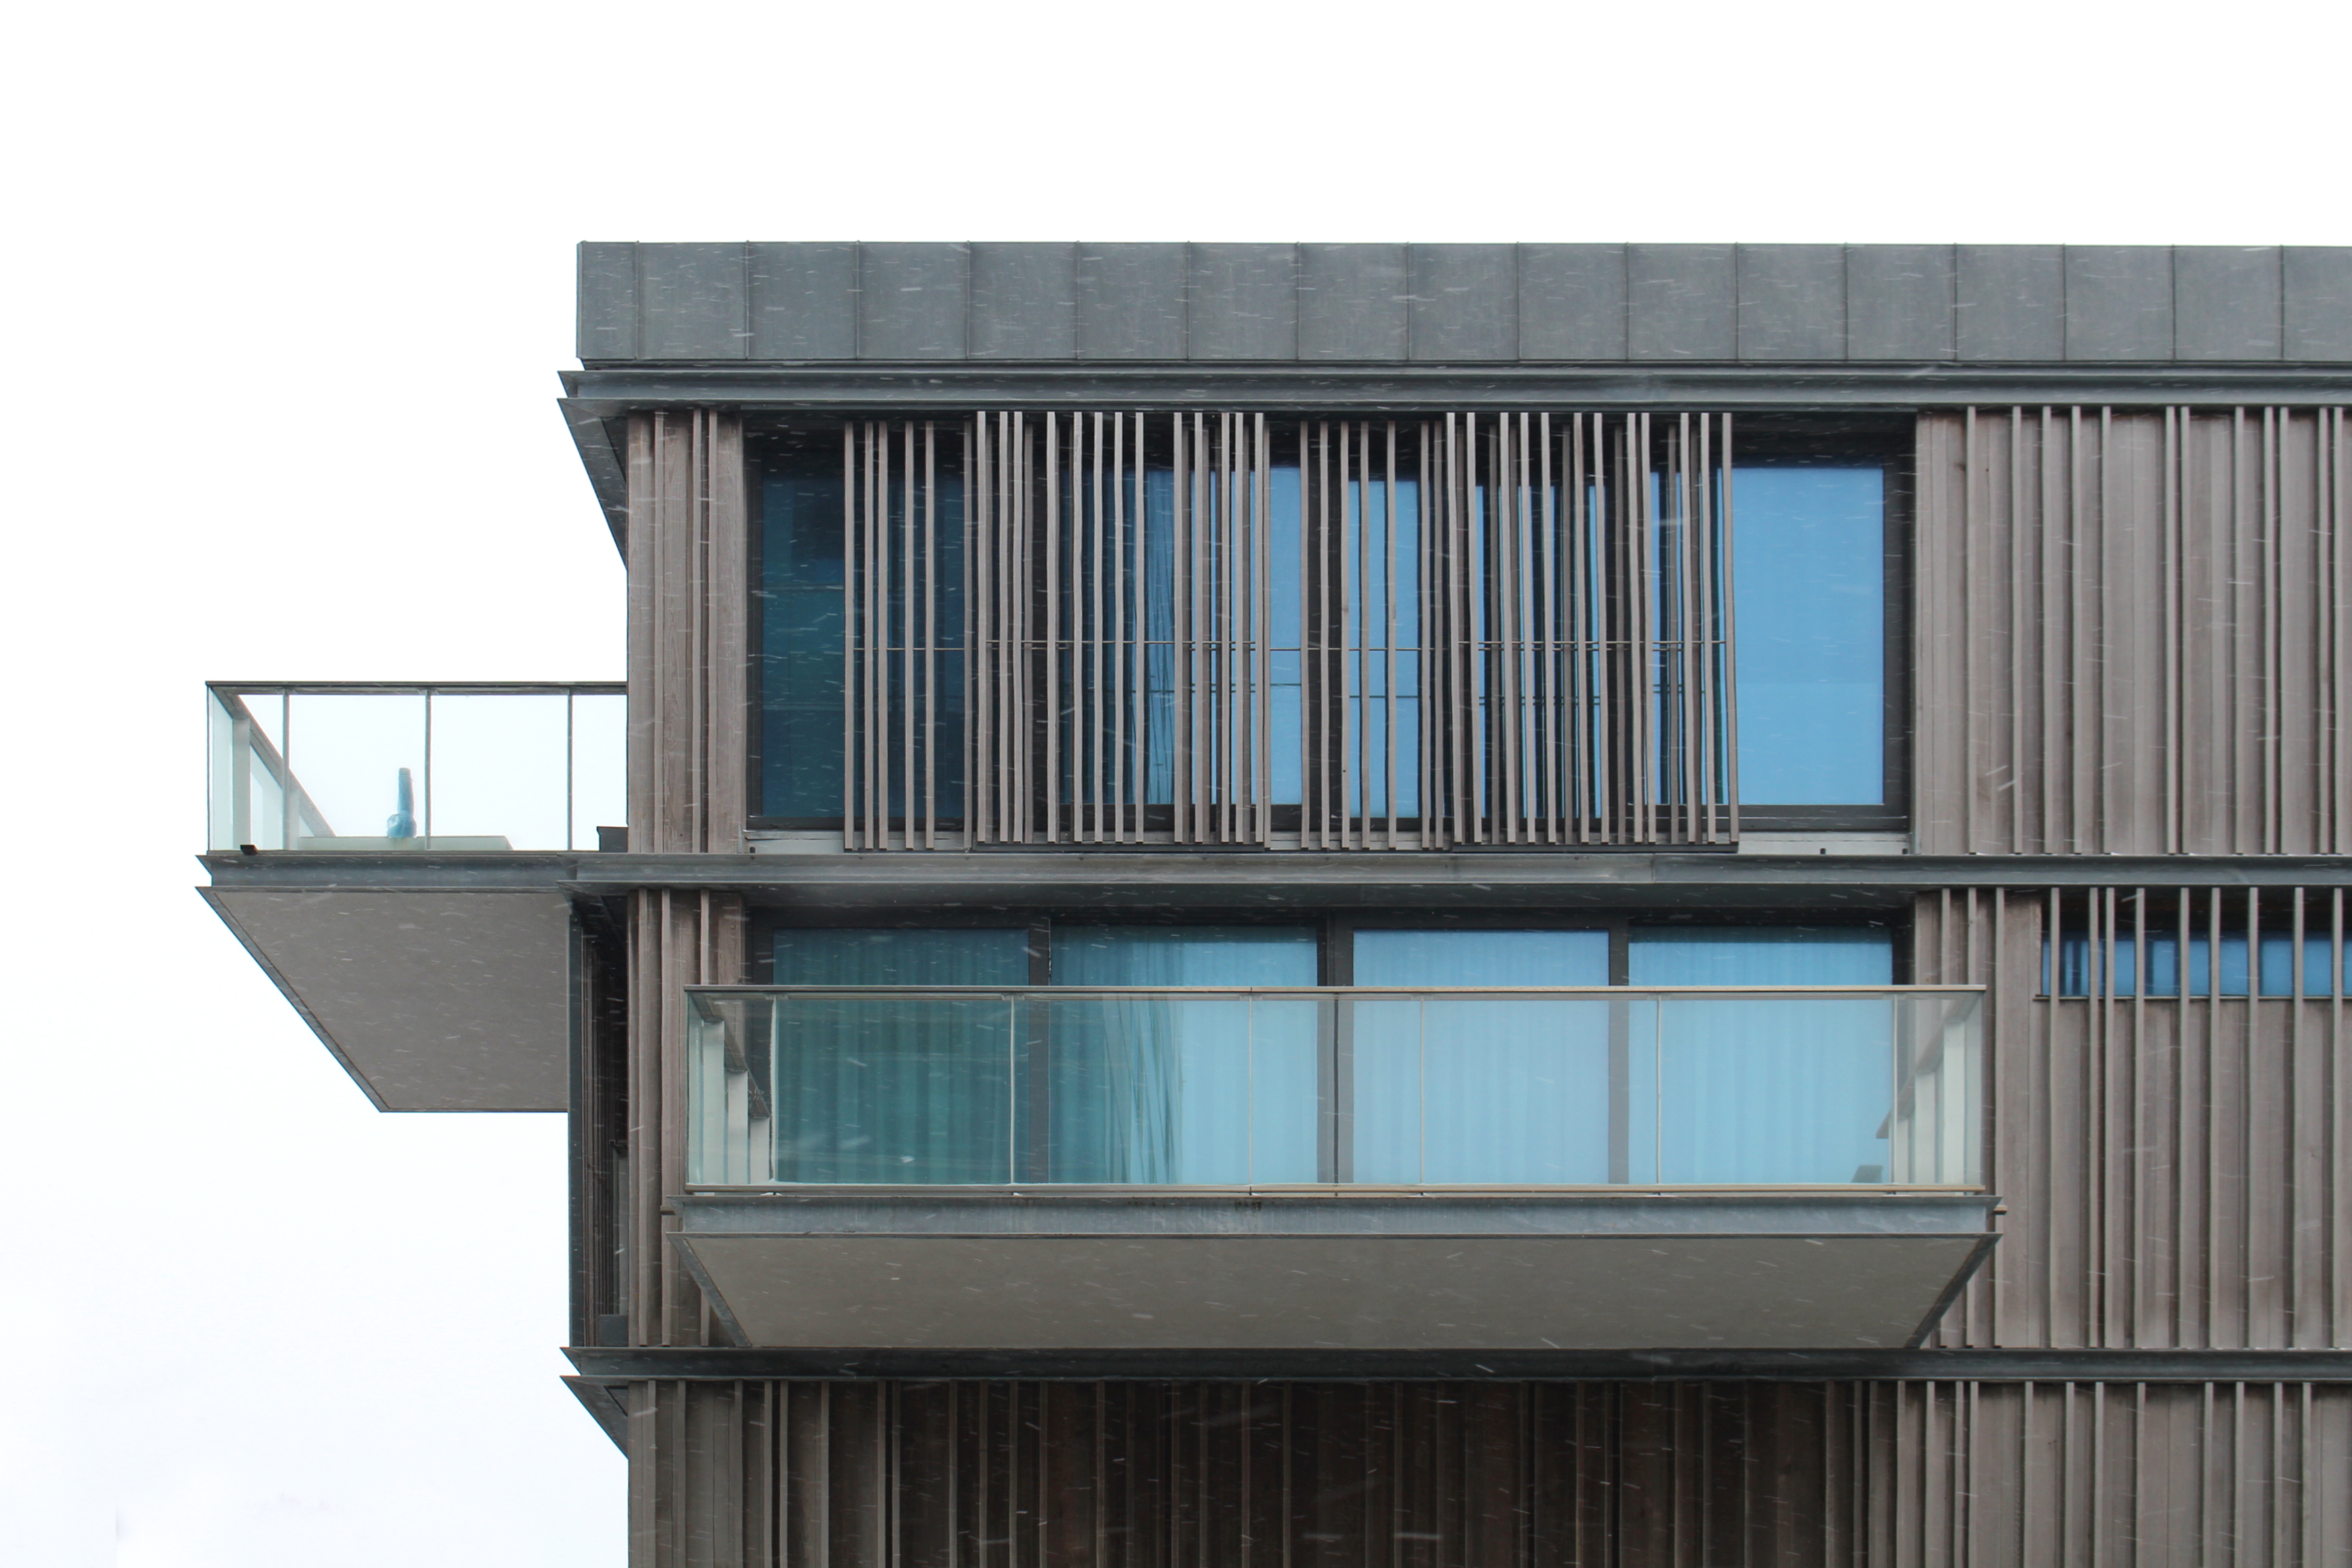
750, 919, 1926, 1185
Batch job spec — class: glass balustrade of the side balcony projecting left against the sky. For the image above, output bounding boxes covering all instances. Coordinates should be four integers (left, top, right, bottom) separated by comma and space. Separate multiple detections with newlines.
205, 682, 628, 853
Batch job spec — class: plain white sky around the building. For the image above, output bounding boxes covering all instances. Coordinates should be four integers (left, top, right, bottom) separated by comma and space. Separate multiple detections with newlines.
0, 0, 2352, 1568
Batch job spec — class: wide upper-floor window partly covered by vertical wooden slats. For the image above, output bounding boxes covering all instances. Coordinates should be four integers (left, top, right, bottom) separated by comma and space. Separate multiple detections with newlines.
755, 414, 1900, 849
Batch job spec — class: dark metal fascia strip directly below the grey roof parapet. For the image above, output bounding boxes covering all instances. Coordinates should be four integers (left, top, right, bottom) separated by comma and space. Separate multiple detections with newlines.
562, 362, 2352, 421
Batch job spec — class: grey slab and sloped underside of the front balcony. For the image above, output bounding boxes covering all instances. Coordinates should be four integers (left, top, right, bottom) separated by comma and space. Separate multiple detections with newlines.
672, 1190, 1995, 1352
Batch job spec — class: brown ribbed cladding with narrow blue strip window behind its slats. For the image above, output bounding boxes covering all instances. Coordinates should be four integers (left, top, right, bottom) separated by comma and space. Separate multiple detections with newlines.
1912, 886, 2352, 1350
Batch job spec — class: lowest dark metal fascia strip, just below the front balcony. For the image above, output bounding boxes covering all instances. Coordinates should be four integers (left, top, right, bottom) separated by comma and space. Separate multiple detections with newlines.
564, 1347, 2352, 1382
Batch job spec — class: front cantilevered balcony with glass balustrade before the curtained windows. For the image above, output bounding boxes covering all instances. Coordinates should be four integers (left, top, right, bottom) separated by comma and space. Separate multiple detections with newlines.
675, 987, 1992, 1350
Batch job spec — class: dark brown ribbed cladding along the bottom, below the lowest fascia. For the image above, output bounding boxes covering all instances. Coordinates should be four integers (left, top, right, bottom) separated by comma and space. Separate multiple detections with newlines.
630, 1382, 2352, 1568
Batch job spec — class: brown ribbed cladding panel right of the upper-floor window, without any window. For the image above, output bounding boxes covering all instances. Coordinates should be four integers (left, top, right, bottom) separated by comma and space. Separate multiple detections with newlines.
1914, 407, 2352, 853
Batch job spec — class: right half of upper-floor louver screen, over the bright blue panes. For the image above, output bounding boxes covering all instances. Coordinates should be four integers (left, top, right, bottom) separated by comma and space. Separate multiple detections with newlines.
1301, 414, 1738, 849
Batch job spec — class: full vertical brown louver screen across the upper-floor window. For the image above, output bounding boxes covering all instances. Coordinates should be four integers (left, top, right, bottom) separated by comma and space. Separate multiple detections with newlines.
845, 411, 1738, 849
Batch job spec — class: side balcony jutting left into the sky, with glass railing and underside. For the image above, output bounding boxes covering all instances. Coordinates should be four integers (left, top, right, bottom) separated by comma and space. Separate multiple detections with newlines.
205, 682, 625, 1109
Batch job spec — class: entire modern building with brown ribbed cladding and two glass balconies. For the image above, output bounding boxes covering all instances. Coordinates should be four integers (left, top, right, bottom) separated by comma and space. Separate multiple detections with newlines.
205, 242, 2352, 1568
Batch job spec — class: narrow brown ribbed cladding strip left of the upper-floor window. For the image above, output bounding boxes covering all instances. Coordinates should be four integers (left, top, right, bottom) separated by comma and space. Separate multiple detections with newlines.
628, 409, 750, 853
